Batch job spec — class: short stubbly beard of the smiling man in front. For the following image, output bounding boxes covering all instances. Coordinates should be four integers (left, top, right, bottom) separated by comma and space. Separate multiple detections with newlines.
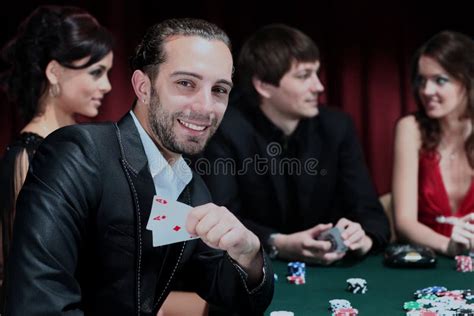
148, 88, 219, 155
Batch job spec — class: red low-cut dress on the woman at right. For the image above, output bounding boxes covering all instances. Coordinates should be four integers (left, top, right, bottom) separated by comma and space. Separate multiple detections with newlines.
418, 150, 474, 237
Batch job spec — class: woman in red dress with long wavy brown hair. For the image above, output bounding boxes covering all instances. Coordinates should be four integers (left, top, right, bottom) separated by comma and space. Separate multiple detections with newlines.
393, 31, 474, 256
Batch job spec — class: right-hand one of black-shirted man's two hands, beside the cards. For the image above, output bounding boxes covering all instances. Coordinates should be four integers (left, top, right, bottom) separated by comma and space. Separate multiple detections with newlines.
336, 217, 373, 256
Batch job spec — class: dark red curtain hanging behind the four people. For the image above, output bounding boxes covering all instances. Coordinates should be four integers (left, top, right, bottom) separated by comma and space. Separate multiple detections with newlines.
0, 0, 474, 193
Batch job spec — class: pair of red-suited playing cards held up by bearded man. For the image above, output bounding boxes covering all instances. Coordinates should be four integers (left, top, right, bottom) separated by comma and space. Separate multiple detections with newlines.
146, 195, 198, 247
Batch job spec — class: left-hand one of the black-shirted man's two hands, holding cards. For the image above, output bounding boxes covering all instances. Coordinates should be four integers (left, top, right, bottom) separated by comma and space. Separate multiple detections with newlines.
274, 224, 345, 265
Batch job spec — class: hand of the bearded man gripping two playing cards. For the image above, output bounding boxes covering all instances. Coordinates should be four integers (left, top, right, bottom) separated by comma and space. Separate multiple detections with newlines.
186, 203, 263, 281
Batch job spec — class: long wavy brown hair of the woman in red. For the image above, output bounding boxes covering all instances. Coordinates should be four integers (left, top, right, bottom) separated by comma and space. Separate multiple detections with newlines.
412, 31, 474, 168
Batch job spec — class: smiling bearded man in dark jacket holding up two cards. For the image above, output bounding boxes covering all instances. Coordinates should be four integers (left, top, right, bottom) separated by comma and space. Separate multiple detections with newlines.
6, 19, 273, 315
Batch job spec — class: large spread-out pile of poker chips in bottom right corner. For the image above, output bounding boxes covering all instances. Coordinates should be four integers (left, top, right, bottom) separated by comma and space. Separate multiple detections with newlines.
403, 286, 474, 316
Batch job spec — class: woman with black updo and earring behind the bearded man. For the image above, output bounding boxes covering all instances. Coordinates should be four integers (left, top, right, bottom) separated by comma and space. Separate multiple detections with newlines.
0, 6, 113, 276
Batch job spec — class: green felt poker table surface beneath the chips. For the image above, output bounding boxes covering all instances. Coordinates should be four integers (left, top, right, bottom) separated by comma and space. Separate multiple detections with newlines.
265, 254, 474, 316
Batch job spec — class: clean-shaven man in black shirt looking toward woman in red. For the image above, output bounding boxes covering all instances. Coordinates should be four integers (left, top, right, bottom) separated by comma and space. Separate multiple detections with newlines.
196, 25, 389, 264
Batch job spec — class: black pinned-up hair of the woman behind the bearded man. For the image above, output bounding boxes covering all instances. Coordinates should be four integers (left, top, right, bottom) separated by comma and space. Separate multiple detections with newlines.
0, 6, 112, 121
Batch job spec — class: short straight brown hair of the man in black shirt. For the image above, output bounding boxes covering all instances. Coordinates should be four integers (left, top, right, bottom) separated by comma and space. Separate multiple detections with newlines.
237, 24, 319, 107
